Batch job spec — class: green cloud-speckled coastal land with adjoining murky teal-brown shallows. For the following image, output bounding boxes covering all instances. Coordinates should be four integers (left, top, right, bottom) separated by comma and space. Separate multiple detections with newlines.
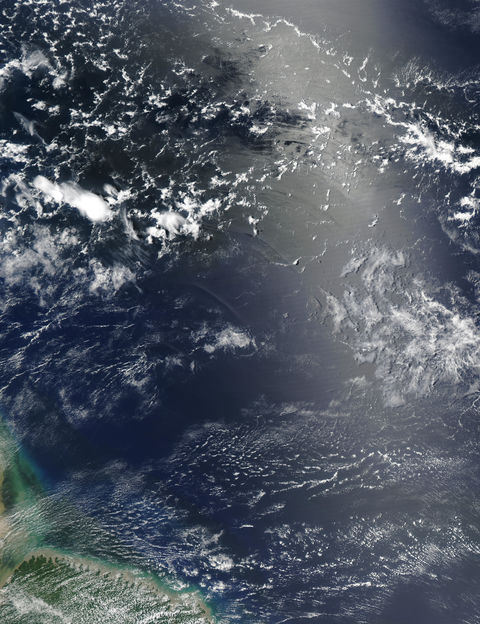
0, 424, 214, 624
